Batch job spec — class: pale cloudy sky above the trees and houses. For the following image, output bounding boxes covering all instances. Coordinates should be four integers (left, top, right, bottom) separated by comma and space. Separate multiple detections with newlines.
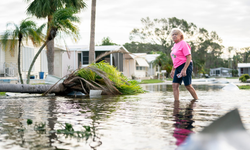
0, 0, 250, 47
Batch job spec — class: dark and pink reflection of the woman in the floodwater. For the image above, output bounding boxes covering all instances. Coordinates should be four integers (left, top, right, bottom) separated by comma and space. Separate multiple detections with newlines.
173, 100, 195, 146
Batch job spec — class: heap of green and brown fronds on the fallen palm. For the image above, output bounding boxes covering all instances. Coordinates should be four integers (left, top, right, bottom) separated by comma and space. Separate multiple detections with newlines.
44, 50, 143, 95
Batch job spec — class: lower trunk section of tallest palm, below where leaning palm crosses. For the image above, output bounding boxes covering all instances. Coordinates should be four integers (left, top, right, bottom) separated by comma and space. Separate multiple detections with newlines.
47, 39, 54, 75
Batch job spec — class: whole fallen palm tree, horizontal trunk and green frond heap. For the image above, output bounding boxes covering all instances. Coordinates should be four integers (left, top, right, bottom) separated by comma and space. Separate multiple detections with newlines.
0, 61, 144, 95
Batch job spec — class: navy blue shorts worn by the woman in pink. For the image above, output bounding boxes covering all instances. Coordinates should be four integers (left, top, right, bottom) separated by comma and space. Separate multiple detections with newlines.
173, 62, 193, 86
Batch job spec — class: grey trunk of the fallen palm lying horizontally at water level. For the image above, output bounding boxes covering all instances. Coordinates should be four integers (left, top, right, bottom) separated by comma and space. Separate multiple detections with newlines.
0, 83, 65, 93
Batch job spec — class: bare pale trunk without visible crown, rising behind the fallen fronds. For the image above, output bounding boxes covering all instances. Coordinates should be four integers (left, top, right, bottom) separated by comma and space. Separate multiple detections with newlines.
89, 0, 96, 64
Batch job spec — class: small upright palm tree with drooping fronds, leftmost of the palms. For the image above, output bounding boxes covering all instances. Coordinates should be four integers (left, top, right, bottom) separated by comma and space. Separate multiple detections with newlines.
1, 19, 41, 84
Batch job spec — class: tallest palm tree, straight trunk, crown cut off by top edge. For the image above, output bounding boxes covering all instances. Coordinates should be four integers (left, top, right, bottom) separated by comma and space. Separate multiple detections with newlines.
26, 0, 86, 75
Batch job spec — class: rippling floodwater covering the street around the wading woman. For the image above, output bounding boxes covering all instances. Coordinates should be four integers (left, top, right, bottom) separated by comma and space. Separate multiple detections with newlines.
0, 84, 250, 150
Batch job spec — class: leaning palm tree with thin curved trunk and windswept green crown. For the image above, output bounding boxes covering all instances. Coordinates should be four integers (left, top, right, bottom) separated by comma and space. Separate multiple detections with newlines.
27, 8, 80, 84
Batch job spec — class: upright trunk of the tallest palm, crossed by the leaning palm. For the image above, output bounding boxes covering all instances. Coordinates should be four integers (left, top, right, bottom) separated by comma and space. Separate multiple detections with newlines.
47, 15, 54, 75
